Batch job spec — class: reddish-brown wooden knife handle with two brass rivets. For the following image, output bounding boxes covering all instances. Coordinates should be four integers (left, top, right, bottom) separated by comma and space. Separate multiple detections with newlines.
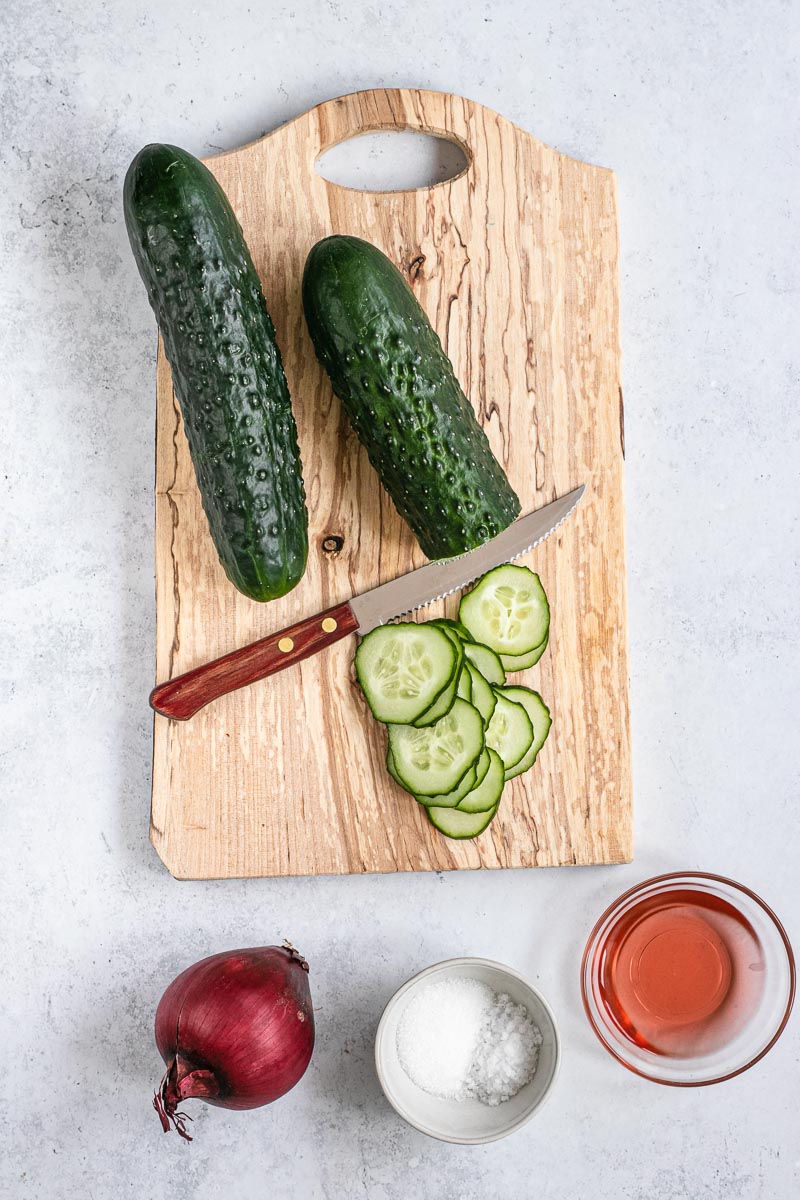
150, 604, 359, 721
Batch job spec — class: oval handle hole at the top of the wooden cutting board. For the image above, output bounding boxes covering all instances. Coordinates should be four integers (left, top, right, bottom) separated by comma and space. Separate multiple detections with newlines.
314, 130, 470, 192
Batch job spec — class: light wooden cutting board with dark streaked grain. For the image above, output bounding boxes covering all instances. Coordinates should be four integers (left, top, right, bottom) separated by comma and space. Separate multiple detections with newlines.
151, 82, 632, 878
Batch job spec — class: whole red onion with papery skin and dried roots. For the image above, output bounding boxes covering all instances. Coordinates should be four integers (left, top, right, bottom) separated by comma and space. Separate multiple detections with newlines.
152, 942, 314, 1141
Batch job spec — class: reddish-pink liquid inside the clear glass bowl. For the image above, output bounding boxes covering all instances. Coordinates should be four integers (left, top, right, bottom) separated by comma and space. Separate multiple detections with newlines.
599, 887, 765, 1058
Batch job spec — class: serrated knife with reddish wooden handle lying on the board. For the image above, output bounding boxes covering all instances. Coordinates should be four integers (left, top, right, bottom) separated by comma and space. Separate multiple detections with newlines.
150, 485, 584, 721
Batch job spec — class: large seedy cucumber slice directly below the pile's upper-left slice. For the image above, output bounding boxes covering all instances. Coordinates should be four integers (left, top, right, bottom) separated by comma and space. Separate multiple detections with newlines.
389, 700, 482, 796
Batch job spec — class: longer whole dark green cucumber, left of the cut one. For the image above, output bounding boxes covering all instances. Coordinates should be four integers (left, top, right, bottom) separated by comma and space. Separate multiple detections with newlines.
124, 144, 308, 600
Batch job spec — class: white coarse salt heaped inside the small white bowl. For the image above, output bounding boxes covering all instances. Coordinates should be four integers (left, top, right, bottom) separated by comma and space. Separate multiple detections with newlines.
397, 976, 542, 1105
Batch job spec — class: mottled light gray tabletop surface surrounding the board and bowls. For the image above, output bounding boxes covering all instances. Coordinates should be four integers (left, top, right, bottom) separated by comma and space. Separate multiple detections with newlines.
0, 0, 800, 1200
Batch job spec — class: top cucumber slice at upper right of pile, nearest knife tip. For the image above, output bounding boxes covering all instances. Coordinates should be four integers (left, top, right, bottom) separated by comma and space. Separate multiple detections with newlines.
458, 563, 551, 657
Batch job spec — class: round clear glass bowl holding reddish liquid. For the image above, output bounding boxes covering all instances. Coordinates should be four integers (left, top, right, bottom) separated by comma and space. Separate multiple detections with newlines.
581, 871, 795, 1087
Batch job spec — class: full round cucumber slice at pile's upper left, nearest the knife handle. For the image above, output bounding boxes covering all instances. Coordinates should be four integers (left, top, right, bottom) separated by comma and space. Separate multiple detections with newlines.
355, 622, 459, 725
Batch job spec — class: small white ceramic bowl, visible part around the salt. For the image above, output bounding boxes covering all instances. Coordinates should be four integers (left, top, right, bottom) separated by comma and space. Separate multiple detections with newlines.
375, 959, 561, 1146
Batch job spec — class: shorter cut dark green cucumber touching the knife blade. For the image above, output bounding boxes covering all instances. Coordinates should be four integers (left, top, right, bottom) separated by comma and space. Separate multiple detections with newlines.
302, 235, 519, 558
